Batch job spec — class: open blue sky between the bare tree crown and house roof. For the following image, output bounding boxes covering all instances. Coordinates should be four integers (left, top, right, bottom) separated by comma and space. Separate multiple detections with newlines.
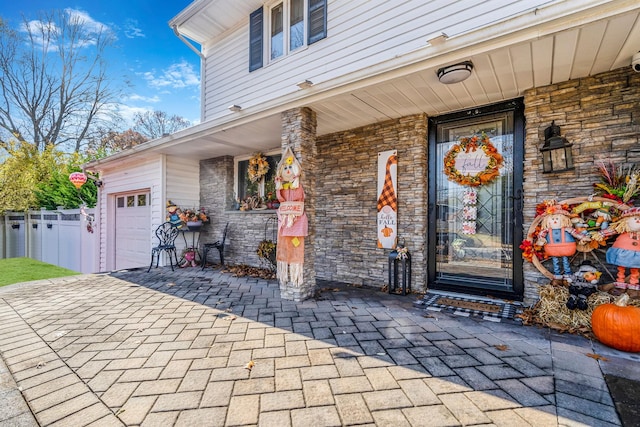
0, 0, 200, 124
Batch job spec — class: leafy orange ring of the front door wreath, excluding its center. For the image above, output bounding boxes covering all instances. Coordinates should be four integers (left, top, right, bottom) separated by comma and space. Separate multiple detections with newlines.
444, 133, 502, 187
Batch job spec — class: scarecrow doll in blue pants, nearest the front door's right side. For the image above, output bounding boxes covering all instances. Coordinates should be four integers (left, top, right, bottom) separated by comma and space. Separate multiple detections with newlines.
536, 205, 590, 282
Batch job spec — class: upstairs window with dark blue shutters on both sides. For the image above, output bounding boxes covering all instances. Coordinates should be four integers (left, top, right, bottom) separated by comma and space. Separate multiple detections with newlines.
249, 0, 327, 71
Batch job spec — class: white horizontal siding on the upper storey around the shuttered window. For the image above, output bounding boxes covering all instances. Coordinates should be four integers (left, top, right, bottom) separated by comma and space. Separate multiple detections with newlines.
203, 0, 555, 120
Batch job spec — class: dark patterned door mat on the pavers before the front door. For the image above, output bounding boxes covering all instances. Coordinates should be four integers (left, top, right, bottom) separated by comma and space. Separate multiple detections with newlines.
416, 292, 519, 322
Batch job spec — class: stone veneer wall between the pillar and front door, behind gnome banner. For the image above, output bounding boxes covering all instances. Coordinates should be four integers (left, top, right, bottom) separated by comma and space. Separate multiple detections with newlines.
315, 115, 427, 289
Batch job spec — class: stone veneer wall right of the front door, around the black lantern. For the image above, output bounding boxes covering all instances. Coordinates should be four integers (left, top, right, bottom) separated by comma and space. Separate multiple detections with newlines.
524, 67, 640, 301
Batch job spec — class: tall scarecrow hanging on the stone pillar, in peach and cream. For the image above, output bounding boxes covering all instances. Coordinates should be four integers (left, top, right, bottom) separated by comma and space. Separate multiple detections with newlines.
275, 148, 309, 287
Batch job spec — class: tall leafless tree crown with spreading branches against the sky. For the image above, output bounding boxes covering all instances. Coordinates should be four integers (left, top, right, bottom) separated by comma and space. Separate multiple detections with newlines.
0, 9, 117, 152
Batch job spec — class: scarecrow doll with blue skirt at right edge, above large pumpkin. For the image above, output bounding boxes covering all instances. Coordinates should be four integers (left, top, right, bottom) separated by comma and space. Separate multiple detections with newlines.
593, 207, 640, 298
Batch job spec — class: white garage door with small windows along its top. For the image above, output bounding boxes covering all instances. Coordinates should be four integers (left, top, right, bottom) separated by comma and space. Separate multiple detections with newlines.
116, 191, 151, 270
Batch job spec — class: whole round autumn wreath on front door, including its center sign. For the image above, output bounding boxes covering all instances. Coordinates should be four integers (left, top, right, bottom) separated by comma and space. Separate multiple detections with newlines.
444, 133, 502, 187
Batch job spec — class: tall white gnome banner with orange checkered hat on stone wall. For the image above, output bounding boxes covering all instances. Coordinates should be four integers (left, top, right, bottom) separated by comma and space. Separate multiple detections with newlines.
377, 150, 398, 249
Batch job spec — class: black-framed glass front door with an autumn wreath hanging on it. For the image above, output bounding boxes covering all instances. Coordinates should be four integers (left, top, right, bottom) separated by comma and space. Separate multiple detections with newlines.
428, 100, 524, 300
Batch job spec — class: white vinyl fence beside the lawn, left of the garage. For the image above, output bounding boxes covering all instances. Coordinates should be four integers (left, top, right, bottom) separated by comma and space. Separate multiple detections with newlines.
0, 209, 98, 273
